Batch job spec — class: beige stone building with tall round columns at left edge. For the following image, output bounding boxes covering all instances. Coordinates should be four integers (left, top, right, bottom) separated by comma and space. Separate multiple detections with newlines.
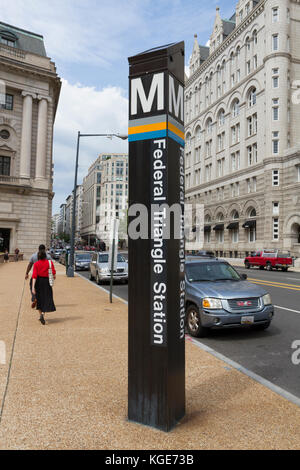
0, 23, 61, 257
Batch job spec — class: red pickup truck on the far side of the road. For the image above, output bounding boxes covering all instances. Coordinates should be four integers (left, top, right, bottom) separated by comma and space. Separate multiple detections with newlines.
244, 250, 293, 271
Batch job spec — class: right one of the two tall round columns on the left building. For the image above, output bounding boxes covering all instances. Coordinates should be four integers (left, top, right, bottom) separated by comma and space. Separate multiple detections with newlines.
35, 95, 50, 179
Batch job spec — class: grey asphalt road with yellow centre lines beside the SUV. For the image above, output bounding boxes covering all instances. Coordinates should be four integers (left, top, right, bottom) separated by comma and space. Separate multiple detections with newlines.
78, 268, 300, 398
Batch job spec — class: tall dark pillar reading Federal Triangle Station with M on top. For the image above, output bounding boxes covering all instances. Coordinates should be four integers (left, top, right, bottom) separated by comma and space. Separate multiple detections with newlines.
128, 42, 185, 431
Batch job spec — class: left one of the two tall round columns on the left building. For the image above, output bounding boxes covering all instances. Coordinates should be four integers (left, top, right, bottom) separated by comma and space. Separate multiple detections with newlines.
20, 91, 36, 178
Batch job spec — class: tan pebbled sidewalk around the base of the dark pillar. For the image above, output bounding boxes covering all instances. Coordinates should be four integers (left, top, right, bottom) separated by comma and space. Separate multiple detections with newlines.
0, 262, 300, 450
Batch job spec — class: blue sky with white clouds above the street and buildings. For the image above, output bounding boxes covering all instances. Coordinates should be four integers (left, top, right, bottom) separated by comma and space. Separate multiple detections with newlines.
0, 0, 237, 214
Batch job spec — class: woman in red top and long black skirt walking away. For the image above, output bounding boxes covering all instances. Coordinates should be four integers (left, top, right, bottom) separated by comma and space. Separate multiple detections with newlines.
32, 249, 56, 325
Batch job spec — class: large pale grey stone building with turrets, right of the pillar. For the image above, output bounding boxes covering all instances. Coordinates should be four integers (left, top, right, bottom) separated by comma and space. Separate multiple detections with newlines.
185, 0, 300, 257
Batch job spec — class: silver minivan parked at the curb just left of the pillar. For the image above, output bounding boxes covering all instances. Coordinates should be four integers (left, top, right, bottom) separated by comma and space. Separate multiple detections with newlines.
90, 252, 128, 284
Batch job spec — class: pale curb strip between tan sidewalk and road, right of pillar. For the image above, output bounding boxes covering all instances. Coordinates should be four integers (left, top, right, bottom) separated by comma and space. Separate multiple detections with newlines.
189, 337, 300, 407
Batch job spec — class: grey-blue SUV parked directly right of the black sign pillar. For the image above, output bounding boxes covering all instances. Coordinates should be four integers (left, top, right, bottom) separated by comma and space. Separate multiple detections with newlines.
186, 257, 274, 337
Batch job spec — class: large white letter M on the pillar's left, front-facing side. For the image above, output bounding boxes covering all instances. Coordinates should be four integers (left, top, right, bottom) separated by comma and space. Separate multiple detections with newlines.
131, 73, 164, 115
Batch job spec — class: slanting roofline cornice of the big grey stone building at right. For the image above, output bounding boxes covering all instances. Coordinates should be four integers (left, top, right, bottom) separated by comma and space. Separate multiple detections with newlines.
185, 0, 266, 87
